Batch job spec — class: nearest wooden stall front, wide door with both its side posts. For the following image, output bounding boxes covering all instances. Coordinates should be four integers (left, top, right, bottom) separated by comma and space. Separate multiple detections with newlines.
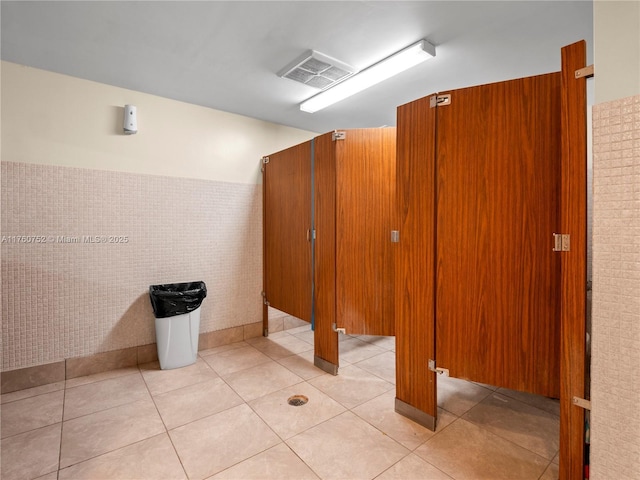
395, 41, 587, 480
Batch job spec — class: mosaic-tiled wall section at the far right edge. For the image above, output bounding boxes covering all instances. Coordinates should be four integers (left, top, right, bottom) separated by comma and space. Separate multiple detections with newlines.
591, 96, 640, 480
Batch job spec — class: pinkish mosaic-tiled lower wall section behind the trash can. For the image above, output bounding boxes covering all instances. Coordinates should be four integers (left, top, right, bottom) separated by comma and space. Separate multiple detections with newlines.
1, 162, 262, 371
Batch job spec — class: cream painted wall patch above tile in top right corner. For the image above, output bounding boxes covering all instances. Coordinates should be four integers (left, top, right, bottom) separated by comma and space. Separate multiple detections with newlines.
593, 0, 640, 103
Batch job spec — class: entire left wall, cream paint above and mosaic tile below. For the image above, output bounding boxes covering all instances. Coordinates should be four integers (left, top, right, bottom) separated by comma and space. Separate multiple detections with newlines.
0, 62, 314, 371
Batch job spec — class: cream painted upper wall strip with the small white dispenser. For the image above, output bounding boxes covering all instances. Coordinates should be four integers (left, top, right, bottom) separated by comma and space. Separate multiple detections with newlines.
2, 62, 315, 184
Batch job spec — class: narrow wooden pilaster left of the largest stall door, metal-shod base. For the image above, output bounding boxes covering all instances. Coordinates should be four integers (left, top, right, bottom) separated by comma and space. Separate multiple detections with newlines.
393, 96, 437, 430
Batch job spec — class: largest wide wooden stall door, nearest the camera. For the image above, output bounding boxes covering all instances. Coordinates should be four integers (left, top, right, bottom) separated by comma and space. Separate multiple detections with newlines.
436, 73, 560, 398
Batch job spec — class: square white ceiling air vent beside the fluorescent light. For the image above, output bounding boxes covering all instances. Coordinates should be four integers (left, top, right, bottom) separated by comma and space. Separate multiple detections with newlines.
278, 50, 356, 90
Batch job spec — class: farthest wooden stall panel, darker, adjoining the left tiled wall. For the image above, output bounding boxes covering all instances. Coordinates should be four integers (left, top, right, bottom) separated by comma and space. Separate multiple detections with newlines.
263, 142, 312, 328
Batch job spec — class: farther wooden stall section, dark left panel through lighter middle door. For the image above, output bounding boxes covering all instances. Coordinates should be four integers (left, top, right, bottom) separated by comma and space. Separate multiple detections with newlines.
263, 127, 396, 375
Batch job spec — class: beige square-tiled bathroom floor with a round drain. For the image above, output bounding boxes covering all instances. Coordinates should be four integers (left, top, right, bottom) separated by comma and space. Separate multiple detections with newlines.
1, 326, 559, 480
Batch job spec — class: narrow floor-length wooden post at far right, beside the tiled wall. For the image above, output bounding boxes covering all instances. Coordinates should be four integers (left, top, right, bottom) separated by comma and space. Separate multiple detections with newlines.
560, 40, 587, 480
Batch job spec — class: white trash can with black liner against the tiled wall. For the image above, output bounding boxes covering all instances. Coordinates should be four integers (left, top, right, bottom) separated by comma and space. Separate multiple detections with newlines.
149, 282, 207, 370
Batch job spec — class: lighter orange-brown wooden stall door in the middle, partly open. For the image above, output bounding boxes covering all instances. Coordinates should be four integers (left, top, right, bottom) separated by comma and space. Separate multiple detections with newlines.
335, 128, 396, 335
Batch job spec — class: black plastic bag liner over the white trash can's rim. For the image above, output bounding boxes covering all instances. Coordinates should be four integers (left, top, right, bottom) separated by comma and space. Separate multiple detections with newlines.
149, 282, 207, 318
